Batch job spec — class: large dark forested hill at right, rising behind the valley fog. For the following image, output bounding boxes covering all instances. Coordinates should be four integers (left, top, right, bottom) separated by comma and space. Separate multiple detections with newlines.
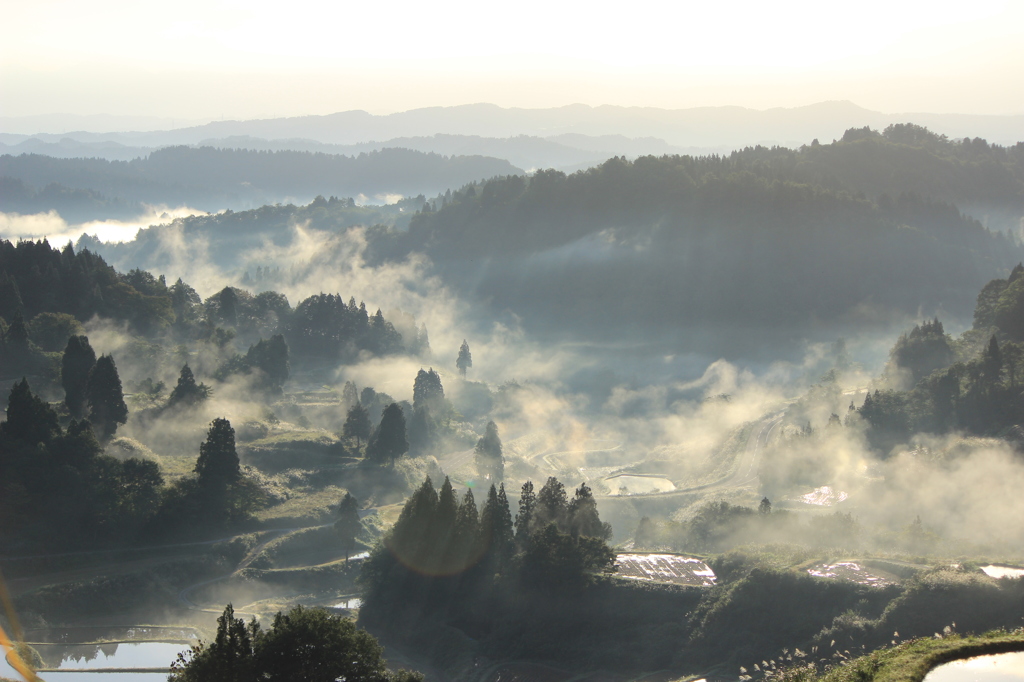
377, 126, 1024, 336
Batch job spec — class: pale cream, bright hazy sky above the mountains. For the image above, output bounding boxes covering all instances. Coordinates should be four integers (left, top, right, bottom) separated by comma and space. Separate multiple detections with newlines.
0, 0, 1024, 119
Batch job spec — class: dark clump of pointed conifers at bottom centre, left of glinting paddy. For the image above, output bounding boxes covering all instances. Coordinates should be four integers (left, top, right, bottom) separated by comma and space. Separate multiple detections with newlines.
360, 477, 614, 623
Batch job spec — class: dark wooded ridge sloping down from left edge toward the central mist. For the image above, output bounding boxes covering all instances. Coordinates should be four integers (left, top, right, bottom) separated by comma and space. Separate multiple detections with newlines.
0, 240, 419, 384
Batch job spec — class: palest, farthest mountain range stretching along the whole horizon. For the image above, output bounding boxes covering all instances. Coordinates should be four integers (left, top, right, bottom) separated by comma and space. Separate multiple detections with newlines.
0, 101, 1024, 169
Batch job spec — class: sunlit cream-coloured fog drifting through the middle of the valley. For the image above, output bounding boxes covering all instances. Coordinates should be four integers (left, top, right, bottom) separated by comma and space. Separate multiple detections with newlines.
8, 205, 1024, 547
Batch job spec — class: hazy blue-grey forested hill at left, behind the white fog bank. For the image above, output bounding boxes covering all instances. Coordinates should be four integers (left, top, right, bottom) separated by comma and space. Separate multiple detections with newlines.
0, 146, 521, 217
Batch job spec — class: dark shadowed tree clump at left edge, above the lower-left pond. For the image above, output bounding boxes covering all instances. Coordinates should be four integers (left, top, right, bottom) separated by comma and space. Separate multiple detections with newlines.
0, 372, 265, 547
